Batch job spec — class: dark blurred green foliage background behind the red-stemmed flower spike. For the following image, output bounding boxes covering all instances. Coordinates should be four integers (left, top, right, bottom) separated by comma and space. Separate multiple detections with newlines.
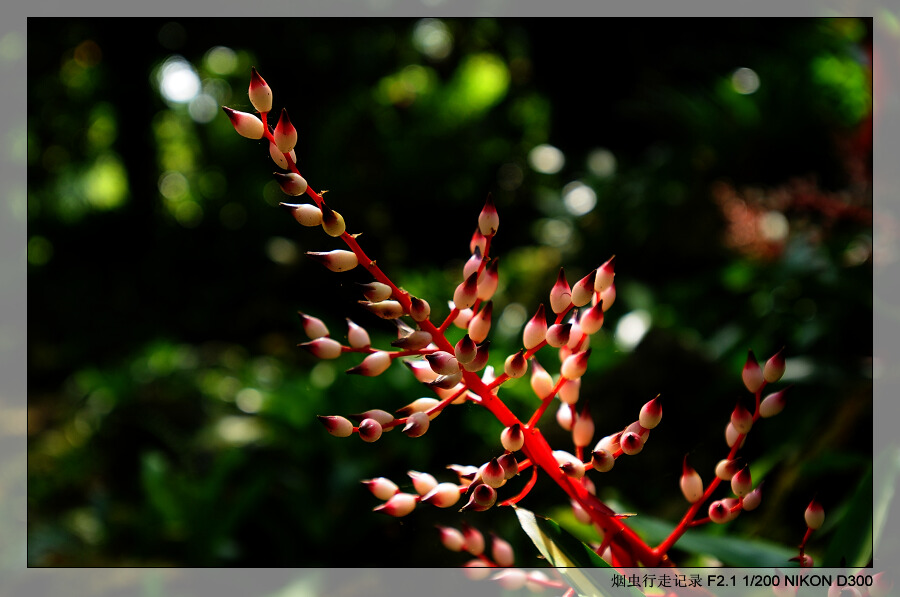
28, 19, 873, 567
